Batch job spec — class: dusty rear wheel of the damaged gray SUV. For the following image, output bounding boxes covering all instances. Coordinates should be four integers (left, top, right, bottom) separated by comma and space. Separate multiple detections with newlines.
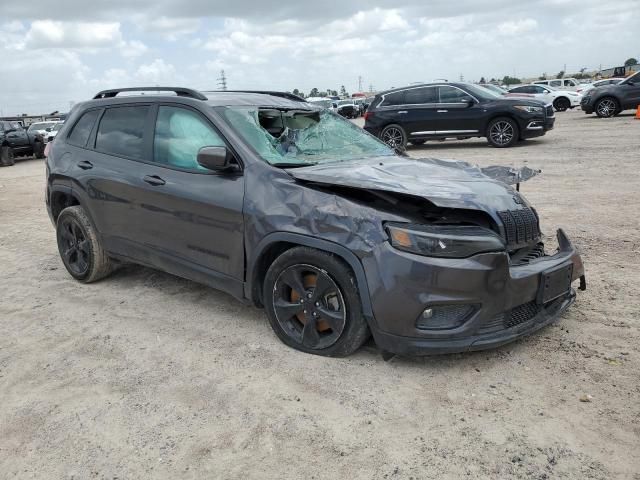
56, 205, 113, 283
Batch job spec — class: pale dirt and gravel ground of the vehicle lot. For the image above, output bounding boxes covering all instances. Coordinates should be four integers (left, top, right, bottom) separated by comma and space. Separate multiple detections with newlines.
0, 112, 640, 479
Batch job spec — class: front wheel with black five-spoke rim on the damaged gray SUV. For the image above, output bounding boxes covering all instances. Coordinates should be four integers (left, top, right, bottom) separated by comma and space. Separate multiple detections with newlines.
263, 247, 369, 357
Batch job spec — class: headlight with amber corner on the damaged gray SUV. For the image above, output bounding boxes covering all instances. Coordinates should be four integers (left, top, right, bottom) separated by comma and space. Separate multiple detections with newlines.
385, 223, 505, 258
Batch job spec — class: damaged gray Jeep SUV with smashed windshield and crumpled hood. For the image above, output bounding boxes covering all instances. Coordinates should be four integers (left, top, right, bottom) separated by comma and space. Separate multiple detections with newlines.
46, 88, 585, 356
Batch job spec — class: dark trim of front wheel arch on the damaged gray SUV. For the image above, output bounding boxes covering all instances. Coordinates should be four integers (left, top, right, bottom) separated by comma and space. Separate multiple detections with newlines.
245, 232, 373, 320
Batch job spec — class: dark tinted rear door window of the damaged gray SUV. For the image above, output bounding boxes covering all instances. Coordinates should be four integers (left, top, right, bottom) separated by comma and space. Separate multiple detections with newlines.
96, 106, 149, 158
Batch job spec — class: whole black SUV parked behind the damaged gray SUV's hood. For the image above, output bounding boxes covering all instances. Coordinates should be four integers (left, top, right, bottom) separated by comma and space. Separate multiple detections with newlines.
364, 83, 555, 149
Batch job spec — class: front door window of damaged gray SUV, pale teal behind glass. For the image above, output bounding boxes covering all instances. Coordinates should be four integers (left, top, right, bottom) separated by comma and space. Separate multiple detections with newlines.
153, 107, 225, 170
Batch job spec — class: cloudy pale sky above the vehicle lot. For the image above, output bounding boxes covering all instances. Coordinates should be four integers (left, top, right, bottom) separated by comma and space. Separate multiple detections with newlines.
0, 0, 640, 116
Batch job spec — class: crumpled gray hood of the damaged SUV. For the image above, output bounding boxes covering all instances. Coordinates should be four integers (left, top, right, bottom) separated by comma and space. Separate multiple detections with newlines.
287, 156, 538, 213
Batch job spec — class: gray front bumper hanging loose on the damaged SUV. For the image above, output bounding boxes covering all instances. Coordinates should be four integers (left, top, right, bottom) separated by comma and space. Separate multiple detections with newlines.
363, 230, 585, 355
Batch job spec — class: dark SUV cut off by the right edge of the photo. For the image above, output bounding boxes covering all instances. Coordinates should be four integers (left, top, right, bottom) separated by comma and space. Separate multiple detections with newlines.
580, 72, 640, 118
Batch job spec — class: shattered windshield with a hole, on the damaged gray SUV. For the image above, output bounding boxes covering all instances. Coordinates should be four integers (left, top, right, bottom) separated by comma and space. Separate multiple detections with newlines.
223, 107, 394, 166
